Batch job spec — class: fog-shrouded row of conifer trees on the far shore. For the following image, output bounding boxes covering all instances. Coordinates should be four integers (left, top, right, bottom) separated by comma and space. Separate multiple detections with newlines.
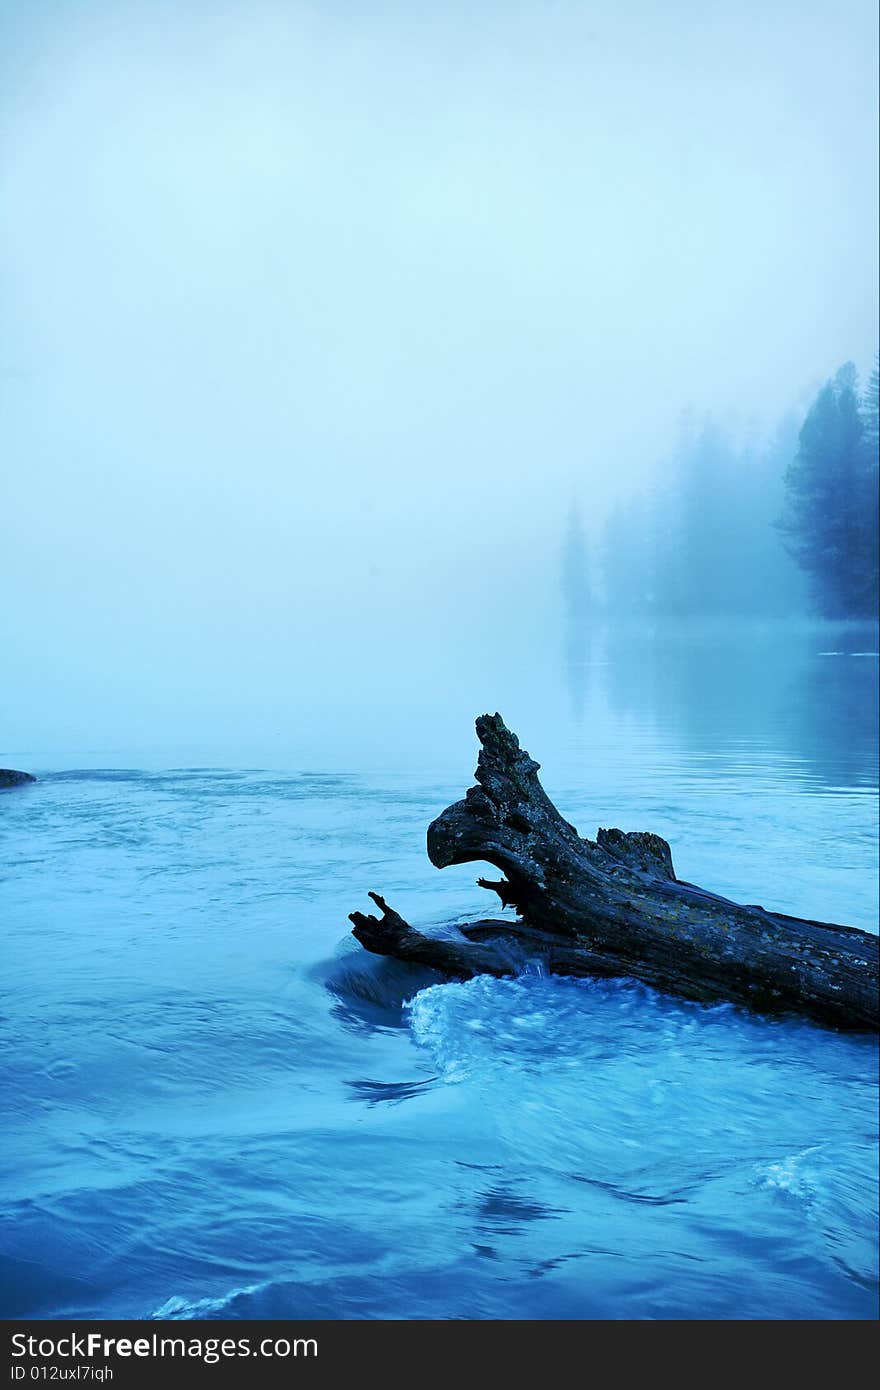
563, 363, 879, 619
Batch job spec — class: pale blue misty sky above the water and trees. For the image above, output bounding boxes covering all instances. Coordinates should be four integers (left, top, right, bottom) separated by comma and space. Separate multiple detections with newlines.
0, 0, 877, 751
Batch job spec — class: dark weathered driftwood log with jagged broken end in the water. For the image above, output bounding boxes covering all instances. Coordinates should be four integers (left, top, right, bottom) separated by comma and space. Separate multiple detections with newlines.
350, 714, 879, 1029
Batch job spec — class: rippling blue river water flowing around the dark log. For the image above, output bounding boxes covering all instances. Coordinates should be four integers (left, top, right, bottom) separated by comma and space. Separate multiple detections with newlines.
0, 632, 877, 1319
